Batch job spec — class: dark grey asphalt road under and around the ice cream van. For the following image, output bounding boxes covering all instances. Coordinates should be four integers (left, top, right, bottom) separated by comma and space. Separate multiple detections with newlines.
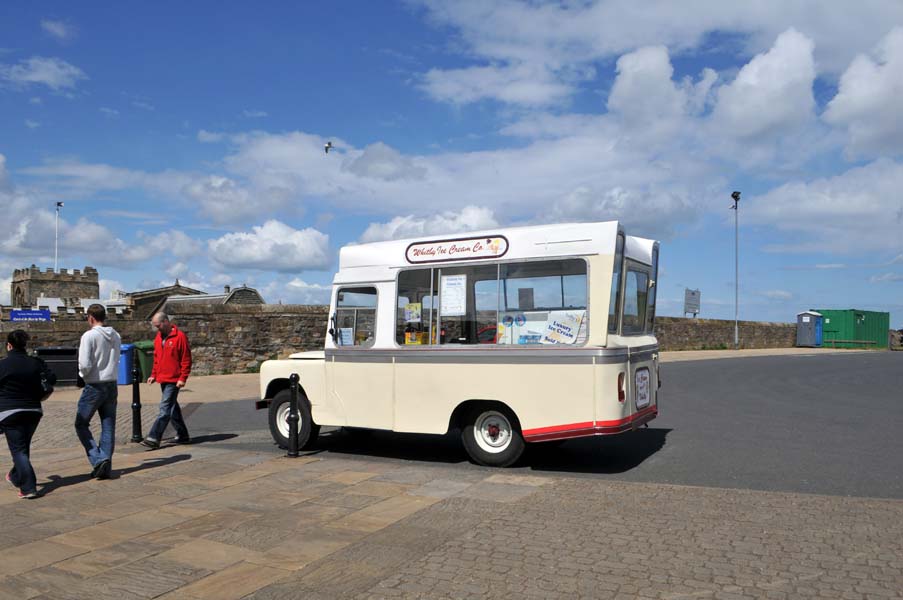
189, 352, 903, 499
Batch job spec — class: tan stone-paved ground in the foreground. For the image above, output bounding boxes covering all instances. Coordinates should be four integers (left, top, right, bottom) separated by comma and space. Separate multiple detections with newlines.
0, 370, 903, 600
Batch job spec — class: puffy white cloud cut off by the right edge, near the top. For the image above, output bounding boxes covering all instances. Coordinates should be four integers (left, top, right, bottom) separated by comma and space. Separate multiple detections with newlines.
824, 27, 903, 156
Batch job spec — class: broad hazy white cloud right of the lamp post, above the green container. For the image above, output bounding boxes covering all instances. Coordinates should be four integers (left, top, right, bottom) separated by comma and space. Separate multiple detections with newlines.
740, 159, 903, 253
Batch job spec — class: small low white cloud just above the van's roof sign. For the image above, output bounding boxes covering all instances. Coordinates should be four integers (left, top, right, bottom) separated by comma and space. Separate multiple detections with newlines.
360, 206, 498, 242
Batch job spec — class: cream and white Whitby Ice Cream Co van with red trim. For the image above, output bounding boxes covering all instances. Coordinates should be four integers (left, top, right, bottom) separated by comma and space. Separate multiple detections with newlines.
257, 221, 659, 467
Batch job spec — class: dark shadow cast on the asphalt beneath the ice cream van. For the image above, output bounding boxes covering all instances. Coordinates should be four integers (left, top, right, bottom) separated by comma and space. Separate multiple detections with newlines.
316, 427, 671, 474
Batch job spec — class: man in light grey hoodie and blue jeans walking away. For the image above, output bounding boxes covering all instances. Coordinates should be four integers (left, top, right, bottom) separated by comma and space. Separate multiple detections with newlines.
75, 304, 122, 479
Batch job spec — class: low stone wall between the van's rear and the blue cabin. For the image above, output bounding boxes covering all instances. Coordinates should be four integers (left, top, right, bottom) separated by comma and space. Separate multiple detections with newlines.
655, 317, 796, 350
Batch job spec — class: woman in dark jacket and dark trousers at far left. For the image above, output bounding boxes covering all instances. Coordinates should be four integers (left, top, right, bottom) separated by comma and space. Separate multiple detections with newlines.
0, 329, 44, 499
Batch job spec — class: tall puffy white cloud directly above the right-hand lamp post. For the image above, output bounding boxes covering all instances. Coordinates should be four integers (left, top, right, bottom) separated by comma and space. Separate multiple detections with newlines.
713, 29, 815, 138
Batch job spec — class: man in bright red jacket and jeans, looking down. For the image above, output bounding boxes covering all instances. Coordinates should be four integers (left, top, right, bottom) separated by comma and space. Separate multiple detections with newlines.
141, 312, 191, 449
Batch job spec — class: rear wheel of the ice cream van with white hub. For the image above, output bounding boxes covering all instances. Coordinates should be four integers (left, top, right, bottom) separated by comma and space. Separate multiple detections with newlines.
461, 405, 525, 467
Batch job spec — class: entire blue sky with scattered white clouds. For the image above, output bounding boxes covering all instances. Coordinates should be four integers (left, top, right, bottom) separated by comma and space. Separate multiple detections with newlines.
0, 0, 903, 328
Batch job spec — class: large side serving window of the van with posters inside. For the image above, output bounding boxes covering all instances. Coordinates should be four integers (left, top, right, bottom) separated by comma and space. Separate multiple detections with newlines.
395, 259, 588, 346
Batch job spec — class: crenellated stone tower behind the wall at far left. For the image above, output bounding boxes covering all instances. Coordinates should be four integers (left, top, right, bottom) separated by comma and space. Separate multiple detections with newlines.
9, 265, 100, 308
